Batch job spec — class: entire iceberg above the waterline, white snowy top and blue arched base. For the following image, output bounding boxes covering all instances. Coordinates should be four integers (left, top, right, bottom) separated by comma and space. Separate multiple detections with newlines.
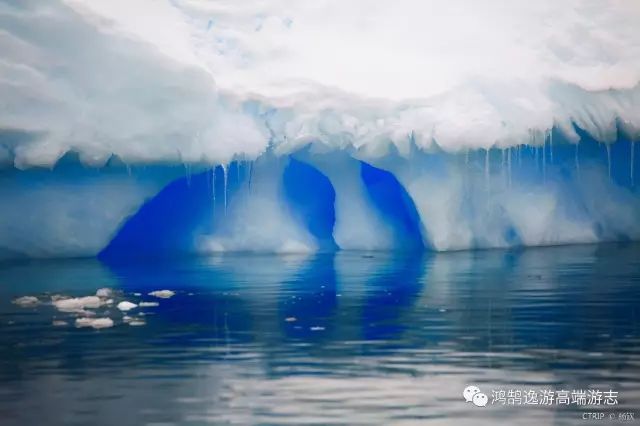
0, 0, 640, 257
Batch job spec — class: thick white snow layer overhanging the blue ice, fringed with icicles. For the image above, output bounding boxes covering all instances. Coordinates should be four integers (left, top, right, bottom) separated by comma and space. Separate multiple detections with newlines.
0, 0, 640, 168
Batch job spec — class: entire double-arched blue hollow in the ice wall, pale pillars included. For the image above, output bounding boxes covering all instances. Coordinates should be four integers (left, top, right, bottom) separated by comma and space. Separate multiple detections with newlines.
100, 157, 423, 259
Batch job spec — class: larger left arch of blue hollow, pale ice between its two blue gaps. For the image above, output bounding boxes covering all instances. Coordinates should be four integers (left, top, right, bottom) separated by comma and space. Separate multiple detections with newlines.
100, 158, 322, 260
